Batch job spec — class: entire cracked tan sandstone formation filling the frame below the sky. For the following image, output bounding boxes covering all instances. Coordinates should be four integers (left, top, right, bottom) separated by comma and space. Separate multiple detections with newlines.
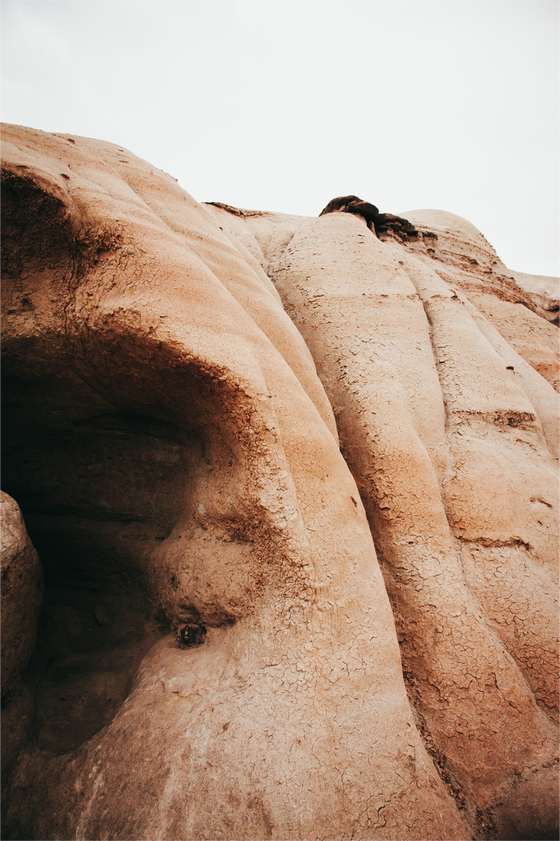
0, 121, 560, 841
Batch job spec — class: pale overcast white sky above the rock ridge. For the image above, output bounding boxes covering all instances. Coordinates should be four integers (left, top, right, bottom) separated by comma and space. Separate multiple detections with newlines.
0, 0, 560, 276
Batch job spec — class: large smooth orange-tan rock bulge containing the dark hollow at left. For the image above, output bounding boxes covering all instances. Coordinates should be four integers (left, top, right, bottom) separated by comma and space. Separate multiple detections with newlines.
0, 127, 469, 841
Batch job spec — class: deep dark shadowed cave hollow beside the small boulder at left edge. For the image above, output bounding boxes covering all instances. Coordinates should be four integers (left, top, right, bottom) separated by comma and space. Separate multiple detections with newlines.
0, 374, 199, 755
